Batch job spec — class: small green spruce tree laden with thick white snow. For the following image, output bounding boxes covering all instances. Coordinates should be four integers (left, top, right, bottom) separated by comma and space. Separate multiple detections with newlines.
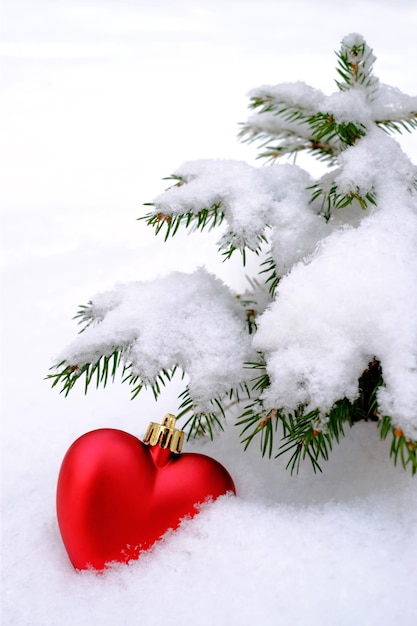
49, 34, 417, 473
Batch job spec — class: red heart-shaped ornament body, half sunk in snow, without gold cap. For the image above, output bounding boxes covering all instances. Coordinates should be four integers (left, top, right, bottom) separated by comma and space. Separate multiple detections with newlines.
57, 428, 235, 570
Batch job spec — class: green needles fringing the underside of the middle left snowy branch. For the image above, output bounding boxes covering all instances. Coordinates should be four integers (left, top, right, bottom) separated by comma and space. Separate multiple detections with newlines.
138, 202, 224, 241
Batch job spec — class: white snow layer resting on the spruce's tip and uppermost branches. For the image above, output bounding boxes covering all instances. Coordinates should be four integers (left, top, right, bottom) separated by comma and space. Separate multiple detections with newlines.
245, 33, 417, 144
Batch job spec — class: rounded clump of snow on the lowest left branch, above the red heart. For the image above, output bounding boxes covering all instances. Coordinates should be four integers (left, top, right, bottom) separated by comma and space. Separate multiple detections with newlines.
58, 269, 252, 409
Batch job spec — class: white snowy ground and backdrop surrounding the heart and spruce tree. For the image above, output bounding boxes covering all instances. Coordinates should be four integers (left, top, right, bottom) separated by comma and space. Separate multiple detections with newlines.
1, 0, 417, 626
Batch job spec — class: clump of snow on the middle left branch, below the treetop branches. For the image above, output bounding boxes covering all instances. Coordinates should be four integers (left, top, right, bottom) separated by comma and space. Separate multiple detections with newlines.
154, 160, 328, 273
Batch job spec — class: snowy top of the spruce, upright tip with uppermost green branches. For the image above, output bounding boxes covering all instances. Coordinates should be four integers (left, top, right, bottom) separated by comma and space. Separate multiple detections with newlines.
241, 33, 417, 163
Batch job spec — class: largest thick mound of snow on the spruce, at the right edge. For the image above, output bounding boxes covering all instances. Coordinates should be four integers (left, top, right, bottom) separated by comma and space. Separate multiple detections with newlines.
254, 131, 417, 439
